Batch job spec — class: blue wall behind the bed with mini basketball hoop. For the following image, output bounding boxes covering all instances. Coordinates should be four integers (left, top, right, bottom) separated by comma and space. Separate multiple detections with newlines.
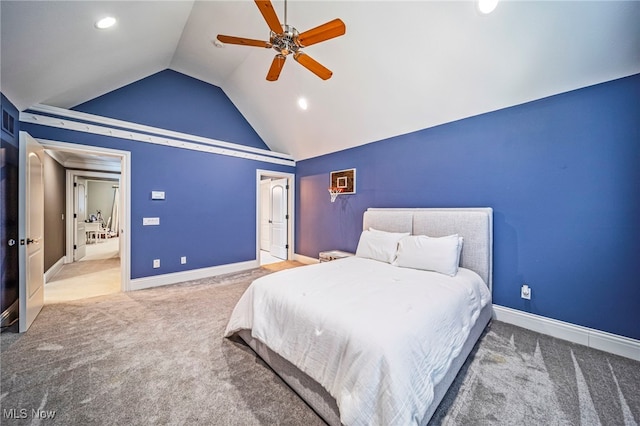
296, 74, 640, 339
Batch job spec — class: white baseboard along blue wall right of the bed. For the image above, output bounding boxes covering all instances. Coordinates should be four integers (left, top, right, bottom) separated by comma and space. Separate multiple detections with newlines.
493, 305, 640, 361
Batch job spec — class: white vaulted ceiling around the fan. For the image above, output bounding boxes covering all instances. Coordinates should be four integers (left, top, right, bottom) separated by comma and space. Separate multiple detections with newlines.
0, 0, 640, 160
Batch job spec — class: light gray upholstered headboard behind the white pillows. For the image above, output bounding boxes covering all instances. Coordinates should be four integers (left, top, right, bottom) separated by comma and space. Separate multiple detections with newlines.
362, 207, 493, 289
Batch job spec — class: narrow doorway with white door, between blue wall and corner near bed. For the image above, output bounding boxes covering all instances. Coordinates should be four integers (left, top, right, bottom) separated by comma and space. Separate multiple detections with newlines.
256, 170, 295, 265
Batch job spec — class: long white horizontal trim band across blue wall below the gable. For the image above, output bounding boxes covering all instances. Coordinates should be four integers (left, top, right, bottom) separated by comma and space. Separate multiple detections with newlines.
20, 105, 295, 167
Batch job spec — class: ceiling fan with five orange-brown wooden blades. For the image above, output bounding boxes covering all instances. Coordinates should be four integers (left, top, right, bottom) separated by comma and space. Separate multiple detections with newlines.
217, 0, 346, 81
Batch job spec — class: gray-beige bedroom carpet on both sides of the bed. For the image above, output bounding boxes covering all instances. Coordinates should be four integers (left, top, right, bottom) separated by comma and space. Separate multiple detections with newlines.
0, 265, 640, 425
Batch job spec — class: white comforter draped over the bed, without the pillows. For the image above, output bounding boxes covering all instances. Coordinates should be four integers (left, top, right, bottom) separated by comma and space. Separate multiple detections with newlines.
225, 257, 491, 425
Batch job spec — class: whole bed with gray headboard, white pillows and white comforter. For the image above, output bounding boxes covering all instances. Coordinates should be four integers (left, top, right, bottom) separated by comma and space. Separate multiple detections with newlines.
225, 208, 493, 425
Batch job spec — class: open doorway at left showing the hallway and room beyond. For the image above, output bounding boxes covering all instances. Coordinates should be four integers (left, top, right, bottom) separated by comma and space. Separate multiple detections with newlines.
41, 141, 131, 303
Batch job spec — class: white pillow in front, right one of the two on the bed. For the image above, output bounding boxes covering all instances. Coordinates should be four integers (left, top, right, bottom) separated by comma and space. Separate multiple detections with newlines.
393, 234, 463, 276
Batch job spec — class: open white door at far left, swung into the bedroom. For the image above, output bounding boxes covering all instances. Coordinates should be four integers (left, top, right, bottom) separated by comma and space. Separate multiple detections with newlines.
18, 132, 44, 333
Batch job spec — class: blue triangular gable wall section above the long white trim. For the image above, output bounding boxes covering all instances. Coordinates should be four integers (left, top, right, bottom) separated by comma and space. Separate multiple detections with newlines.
73, 69, 269, 149
